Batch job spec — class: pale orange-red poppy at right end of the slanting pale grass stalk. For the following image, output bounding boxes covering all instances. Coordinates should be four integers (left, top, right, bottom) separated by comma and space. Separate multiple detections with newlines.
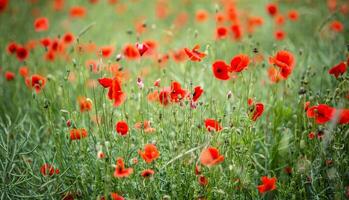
200, 147, 224, 167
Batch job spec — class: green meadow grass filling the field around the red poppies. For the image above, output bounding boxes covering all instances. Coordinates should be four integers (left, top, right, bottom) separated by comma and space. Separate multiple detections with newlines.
0, 0, 349, 199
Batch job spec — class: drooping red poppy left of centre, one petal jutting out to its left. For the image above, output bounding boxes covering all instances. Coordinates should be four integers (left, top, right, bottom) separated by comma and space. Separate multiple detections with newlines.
98, 78, 126, 106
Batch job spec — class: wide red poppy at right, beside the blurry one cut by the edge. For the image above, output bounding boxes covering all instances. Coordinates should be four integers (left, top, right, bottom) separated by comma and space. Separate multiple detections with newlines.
307, 104, 336, 124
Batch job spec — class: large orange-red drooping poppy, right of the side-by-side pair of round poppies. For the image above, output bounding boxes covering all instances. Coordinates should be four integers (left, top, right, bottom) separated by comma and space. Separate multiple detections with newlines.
269, 51, 295, 79
